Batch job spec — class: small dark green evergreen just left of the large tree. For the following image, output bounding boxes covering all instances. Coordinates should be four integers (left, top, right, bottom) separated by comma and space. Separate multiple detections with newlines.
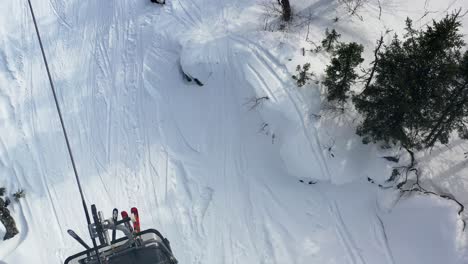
323, 42, 364, 103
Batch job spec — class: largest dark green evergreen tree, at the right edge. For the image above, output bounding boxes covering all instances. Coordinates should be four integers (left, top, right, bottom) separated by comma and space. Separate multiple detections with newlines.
354, 12, 468, 149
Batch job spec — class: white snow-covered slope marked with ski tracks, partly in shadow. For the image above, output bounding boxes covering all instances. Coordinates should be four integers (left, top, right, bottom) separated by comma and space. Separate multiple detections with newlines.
0, 0, 468, 264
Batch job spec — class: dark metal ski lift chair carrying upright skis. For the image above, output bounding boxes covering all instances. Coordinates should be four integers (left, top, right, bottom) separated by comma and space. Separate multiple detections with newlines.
65, 206, 178, 264
